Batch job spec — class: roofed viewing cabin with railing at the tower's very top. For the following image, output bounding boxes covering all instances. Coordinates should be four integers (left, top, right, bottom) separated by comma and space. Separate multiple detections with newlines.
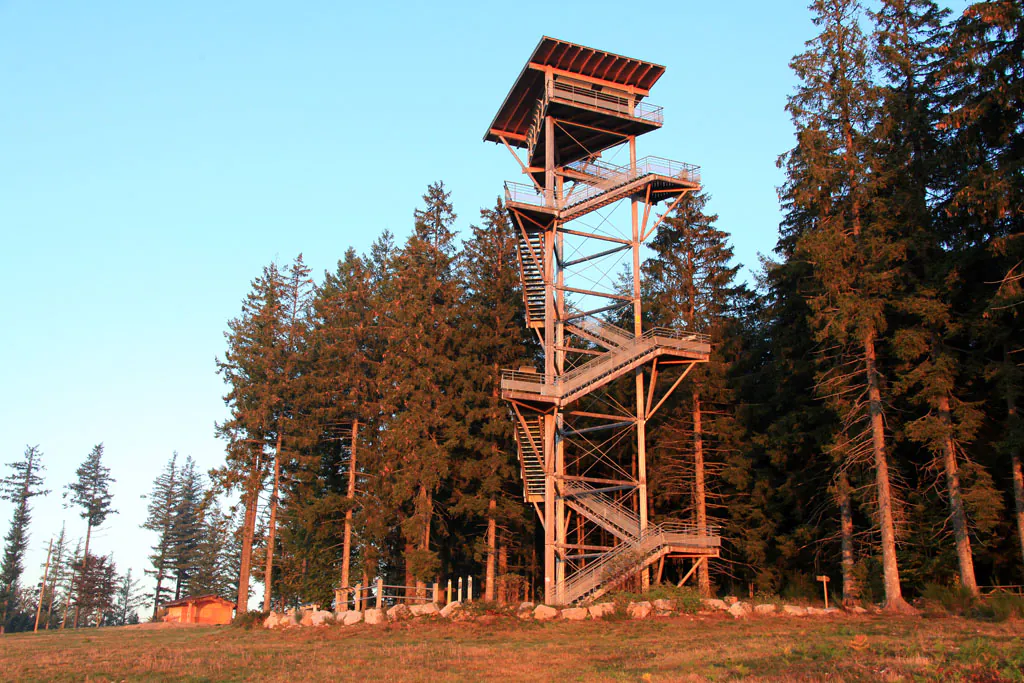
483, 37, 665, 167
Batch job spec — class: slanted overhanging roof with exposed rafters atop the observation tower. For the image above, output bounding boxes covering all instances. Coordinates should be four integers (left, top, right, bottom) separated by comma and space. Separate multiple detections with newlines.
483, 36, 665, 146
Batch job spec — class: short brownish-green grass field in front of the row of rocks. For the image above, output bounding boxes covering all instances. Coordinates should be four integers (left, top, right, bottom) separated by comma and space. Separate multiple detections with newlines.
0, 614, 1024, 681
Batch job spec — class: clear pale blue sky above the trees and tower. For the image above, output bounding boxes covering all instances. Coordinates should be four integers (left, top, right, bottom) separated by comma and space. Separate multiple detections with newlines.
0, 0, 814, 610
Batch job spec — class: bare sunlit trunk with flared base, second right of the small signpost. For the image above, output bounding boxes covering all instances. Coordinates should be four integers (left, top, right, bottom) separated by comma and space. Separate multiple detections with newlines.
864, 330, 912, 611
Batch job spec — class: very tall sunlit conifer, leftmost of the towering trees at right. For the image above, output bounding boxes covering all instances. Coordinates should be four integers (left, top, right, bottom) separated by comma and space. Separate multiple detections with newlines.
783, 0, 909, 610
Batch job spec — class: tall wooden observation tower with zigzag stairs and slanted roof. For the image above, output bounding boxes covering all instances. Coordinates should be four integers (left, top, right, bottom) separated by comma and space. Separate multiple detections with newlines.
484, 38, 721, 605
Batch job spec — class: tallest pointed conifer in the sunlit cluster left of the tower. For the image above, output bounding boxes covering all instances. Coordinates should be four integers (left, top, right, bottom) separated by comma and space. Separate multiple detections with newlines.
379, 182, 459, 586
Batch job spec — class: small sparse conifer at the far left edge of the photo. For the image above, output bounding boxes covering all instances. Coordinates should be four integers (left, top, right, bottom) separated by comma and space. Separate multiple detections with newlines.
0, 445, 49, 629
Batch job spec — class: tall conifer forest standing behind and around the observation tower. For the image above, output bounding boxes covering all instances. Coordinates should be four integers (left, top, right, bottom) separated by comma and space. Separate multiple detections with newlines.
0, 0, 1024, 630
